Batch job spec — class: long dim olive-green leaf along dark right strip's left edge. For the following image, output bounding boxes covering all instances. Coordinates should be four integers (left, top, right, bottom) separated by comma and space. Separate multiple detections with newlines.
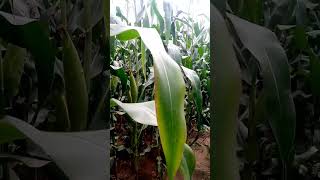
210, 6, 241, 179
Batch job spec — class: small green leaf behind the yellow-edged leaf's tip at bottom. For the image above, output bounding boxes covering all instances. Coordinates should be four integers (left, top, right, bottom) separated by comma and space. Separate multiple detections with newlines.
180, 144, 196, 180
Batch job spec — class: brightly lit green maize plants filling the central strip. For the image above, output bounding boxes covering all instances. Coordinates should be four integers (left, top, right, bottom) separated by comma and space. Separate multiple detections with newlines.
110, 0, 210, 179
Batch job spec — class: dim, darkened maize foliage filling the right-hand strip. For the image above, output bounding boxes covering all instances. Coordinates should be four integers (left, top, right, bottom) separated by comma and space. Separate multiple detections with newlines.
211, 0, 320, 179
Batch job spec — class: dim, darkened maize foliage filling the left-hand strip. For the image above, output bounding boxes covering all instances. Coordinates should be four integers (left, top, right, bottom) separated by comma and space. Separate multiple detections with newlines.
0, 0, 110, 180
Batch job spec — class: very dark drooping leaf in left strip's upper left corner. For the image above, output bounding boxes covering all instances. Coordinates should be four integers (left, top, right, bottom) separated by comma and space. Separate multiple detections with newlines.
0, 11, 56, 102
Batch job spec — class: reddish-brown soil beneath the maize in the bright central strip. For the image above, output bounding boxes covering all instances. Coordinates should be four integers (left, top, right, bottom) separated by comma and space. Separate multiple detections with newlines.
111, 131, 210, 180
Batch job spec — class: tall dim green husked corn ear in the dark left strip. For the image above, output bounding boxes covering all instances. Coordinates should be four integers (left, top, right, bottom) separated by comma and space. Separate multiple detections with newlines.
62, 31, 89, 131
